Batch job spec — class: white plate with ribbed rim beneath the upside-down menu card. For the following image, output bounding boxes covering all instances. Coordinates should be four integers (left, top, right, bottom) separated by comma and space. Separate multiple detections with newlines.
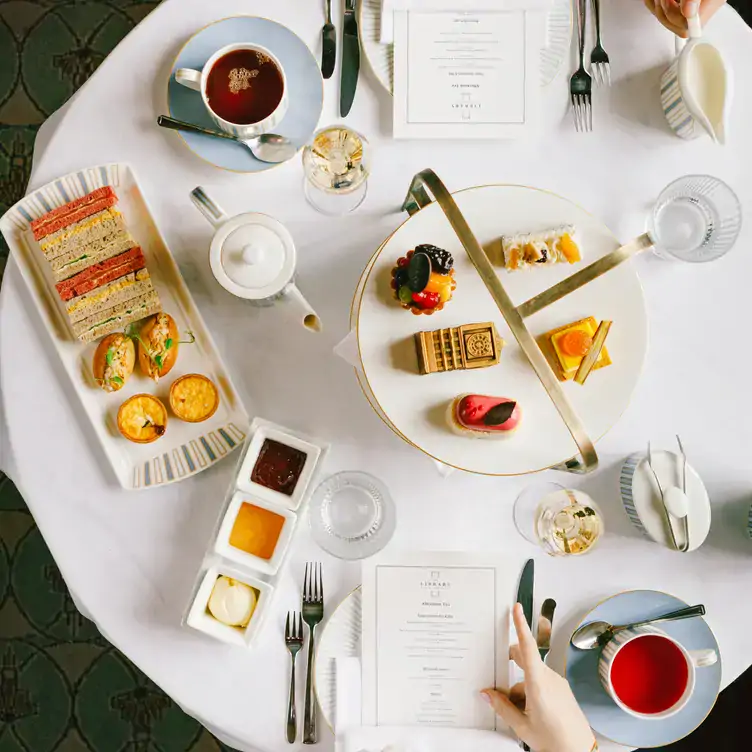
358, 0, 572, 94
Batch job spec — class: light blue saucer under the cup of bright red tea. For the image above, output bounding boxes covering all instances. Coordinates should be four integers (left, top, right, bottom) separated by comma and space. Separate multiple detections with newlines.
567, 590, 721, 748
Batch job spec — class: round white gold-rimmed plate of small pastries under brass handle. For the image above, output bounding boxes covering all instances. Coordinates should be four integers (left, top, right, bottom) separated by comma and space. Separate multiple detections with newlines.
355, 185, 647, 475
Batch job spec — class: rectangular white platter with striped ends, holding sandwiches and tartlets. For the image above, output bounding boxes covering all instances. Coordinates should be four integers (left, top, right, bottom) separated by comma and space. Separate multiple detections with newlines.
0, 164, 249, 490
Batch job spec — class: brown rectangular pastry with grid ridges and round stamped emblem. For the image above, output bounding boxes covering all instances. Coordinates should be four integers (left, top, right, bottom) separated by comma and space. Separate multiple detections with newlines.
415, 321, 504, 374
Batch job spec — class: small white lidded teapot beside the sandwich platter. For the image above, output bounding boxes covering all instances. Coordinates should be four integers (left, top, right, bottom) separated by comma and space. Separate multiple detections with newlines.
191, 186, 321, 332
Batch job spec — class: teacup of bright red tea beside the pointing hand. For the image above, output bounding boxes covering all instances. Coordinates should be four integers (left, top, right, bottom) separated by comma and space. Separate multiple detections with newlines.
598, 626, 718, 719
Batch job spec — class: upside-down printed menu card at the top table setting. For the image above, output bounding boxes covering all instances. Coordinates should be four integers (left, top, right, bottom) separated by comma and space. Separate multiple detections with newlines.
394, 0, 546, 139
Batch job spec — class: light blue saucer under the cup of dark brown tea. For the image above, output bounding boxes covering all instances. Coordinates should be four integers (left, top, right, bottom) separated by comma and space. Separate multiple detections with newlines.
167, 16, 324, 172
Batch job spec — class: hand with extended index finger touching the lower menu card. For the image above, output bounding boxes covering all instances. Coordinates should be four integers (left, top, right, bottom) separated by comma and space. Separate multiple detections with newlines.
481, 603, 595, 752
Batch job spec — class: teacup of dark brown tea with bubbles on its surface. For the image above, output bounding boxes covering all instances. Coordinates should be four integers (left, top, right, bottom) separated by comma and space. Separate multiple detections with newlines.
175, 44, 288, 138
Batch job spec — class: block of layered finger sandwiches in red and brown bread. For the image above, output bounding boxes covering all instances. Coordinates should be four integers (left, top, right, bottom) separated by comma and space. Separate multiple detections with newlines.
31, 186, 162, 342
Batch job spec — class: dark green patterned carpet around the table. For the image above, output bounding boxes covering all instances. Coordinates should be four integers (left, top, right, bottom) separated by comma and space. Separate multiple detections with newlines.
0, 0, 752, 752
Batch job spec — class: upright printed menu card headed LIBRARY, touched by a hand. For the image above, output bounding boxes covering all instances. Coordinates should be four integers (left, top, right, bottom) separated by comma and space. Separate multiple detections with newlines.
362, 553, 519, 730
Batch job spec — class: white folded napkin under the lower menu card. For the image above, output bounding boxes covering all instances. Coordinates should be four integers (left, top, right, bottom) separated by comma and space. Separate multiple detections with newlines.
334, 658, 518, 752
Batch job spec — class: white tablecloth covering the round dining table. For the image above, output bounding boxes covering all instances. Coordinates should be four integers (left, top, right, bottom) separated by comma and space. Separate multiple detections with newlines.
0, 0, 752, 752
